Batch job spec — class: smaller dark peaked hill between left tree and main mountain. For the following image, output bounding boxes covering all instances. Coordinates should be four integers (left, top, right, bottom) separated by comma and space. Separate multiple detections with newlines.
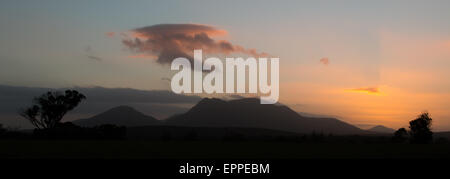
72, 106, 161, 127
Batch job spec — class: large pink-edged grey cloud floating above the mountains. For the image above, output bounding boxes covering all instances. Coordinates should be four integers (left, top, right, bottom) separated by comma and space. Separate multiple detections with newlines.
122, 24, 269, 64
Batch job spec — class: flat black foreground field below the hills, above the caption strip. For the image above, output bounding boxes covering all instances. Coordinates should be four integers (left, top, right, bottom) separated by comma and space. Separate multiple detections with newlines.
0, 140, 450, 159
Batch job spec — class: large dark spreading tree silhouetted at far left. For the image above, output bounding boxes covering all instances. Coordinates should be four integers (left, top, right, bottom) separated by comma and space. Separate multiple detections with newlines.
20, 90, 86, 129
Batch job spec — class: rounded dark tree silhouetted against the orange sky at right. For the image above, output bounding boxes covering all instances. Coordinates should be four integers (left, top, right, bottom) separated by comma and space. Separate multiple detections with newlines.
409, 112, 433, 143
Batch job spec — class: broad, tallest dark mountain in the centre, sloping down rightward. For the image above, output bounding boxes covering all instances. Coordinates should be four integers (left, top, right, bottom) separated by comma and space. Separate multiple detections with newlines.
164, 98, 371, 134
